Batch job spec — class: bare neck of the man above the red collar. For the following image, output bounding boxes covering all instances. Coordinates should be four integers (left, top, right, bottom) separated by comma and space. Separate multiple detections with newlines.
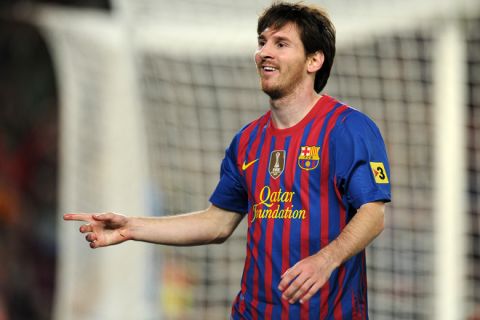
270, 89, 321, 129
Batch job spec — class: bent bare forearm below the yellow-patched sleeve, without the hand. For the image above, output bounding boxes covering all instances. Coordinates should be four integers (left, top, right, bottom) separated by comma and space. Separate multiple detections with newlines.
318, 202, 385, 268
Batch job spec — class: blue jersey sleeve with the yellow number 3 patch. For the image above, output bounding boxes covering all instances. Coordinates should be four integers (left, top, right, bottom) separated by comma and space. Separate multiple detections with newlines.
331, 109, 391, 209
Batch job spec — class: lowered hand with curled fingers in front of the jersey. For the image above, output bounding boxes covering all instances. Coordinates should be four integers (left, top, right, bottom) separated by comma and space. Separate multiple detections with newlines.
278, 251, 335, 303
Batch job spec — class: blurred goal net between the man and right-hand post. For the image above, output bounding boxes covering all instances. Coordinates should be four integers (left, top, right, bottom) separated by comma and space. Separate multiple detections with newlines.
327, 31, 433, 319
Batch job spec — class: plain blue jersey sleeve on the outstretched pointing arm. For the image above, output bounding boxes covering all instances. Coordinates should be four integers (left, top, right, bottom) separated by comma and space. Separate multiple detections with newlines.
210, 134, 248, 214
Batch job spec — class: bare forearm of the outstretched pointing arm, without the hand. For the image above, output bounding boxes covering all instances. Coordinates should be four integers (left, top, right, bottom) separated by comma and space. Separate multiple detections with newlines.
122, 206, 238, 246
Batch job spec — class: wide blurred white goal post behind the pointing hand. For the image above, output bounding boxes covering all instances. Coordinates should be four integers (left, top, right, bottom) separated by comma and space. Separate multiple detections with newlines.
38, 7, 158, 320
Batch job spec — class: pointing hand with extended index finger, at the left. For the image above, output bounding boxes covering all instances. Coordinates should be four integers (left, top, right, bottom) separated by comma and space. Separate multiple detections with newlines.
63, 213, 129, 249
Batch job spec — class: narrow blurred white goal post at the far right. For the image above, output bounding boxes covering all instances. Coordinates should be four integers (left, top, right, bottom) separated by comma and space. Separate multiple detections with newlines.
433, 17, 468, 320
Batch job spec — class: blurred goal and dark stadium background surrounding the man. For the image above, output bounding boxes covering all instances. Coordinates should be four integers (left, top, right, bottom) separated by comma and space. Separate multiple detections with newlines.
0, 0, 480, 320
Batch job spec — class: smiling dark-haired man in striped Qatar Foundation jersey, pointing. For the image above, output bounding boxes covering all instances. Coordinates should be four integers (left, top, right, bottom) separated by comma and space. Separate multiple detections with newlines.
65, 3, 390, 319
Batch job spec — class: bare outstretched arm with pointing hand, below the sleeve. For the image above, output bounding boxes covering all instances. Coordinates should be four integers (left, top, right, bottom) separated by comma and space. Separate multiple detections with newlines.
63, 205, 242, 248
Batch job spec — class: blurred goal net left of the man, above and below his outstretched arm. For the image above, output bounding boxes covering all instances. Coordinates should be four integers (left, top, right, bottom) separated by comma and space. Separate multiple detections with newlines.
140, 53, 267, 319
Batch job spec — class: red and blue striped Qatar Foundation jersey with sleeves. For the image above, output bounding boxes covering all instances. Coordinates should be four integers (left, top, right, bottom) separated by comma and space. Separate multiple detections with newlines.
210, 95, 390, 319
